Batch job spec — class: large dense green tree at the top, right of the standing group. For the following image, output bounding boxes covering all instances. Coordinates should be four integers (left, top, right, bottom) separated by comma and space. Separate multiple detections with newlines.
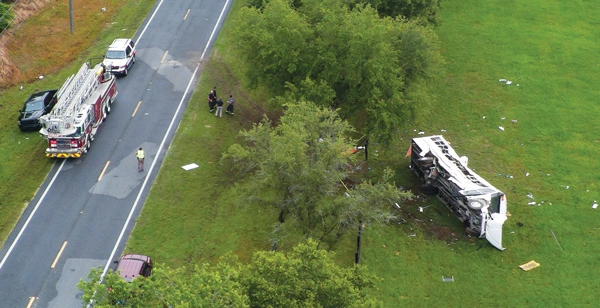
232, 0, 440, 141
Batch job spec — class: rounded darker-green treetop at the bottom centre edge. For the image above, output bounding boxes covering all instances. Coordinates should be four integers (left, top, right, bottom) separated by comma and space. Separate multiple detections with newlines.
243, 240, 377, 308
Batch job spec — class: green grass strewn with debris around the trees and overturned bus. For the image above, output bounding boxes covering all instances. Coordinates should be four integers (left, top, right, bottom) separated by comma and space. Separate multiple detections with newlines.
0, 0, 600, 307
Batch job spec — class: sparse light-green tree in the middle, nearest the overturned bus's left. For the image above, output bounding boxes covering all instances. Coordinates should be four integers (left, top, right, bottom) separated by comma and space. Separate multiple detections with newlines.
223, 102, 411, 244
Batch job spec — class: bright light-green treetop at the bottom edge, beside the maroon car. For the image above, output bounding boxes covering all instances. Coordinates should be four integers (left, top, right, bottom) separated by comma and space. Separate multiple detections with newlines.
78, 258, 250, 307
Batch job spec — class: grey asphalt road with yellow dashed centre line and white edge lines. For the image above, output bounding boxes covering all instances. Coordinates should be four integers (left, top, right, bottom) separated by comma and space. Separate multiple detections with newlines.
0, 0, 233, 308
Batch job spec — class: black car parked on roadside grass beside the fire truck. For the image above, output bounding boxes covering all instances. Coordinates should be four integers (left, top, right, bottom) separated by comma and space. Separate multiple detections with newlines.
19, 90, 57, 131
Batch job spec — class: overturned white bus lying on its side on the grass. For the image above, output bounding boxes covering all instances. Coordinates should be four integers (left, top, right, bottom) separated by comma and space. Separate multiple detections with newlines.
409, 135, 507, 250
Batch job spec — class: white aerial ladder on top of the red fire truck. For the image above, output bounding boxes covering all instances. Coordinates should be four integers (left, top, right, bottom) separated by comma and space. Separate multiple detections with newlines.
50, 63, 98, 119
